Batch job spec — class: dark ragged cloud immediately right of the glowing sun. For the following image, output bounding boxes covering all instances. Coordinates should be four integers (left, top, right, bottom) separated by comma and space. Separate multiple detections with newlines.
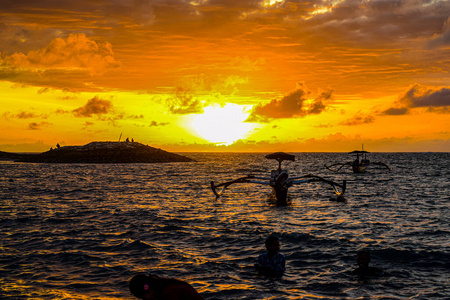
246, 83, 332, 122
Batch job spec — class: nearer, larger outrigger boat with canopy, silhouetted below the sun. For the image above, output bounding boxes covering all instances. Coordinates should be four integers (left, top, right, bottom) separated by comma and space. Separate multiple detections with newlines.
211, 152, 346, 205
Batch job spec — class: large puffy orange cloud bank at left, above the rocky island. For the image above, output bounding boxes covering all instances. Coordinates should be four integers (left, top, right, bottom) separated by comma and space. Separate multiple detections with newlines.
0, 33, 120, 92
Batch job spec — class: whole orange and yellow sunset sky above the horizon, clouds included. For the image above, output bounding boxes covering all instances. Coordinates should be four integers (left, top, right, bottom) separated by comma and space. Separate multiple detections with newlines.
0, 0, 450, 152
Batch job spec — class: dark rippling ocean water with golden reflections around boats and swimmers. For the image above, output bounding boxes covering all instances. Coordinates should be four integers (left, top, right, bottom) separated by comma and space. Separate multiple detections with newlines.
0, 153, 450, 299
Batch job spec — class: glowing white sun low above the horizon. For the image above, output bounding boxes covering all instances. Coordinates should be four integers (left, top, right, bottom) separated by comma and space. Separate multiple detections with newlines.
188, 103, 254, 145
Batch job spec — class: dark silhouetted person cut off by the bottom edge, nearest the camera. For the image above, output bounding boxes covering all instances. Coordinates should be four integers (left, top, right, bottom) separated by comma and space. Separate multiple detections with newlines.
129, 273, 203, 300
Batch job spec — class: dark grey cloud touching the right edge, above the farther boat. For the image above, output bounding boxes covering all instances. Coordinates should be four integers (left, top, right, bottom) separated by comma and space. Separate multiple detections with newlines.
382, 84, 450, 115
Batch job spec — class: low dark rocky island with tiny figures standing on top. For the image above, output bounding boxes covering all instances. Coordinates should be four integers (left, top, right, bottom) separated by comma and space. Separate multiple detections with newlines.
0, 142, 194, 163
